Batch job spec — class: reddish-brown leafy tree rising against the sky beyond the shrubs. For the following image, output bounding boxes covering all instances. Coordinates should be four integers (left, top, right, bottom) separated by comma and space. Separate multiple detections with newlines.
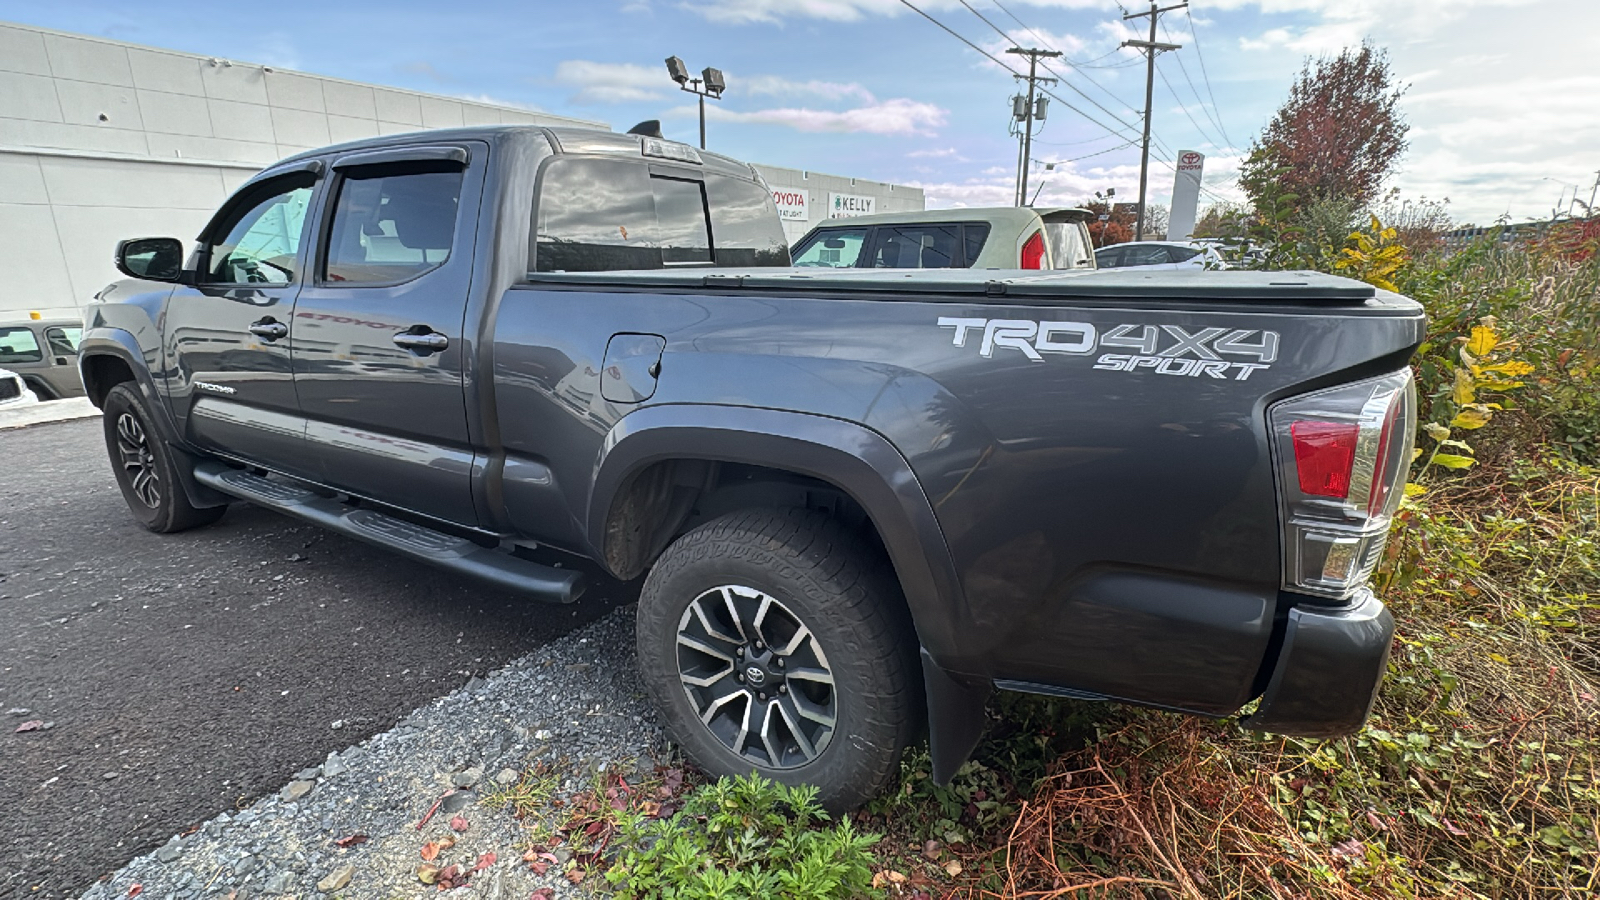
1238, 43, 1410, 207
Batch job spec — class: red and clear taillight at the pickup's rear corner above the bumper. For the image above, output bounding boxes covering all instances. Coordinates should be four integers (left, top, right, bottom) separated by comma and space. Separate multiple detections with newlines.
1267, 368, 1416, 601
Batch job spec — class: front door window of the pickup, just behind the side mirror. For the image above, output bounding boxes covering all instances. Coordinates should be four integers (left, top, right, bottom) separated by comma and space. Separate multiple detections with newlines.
203, 173, 315, 285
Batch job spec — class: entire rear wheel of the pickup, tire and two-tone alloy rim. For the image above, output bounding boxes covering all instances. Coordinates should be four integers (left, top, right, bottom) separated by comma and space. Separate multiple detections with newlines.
637, 509, 922, 812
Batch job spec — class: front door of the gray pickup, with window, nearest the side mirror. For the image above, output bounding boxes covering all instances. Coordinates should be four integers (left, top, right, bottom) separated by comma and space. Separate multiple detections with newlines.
165, 170, 317, 476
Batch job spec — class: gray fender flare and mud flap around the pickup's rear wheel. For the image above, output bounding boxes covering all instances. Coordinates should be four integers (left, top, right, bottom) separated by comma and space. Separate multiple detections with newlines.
586, 404, 992, 783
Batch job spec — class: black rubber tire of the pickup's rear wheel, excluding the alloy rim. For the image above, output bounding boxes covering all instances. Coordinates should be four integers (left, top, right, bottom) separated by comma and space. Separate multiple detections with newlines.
635, 509, 923, 814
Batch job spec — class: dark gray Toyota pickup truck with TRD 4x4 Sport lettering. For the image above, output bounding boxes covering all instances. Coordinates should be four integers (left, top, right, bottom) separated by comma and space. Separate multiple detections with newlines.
80, 127, 1424, 809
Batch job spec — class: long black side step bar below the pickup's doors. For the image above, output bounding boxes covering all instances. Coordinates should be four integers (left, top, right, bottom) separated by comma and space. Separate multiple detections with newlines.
195, 461, 584, 604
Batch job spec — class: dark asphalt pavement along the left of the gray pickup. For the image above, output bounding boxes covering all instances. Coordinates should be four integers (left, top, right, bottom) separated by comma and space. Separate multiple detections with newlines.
0, 418, 637, 900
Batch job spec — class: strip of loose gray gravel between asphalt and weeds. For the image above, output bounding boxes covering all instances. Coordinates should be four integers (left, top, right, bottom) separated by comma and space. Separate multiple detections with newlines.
83, 607, 664, 900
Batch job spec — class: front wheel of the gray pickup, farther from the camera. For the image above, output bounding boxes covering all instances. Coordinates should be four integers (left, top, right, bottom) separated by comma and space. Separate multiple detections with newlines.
101, 384, 227, 535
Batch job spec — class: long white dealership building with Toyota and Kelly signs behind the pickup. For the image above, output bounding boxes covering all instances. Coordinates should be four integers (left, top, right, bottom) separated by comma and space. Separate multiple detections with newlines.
0, 22, 923, 319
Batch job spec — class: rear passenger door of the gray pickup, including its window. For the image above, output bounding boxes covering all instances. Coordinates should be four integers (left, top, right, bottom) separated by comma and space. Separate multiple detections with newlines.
294, 141, 488, 525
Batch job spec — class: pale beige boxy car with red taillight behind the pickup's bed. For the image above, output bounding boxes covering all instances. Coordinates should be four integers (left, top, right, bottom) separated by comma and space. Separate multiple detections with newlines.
792, 207, 1094, 269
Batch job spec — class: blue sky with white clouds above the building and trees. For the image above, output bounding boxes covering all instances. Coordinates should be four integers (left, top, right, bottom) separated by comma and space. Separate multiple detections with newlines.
0, 0, 1600, 224
